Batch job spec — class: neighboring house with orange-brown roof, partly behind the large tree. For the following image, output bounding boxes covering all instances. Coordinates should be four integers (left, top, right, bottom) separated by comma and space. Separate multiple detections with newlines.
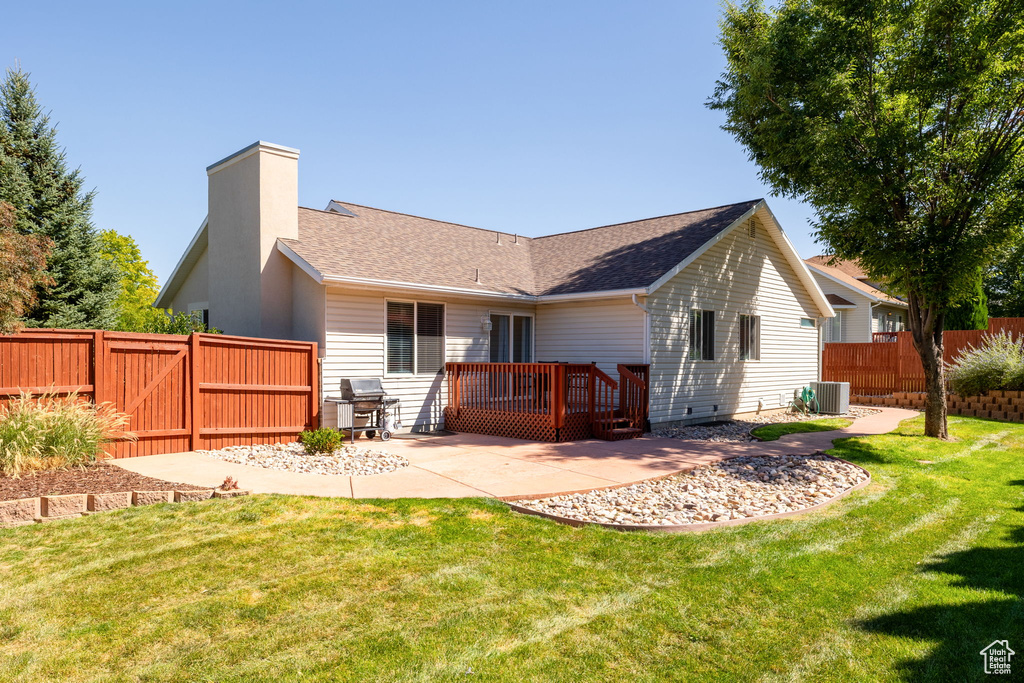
807, 256, 907, 342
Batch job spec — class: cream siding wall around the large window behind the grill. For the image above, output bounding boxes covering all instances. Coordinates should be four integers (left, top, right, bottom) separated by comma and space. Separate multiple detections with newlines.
323, 287, 534, 429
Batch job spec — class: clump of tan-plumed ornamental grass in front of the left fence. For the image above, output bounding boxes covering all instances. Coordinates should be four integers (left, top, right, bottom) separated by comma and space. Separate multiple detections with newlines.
0, 393, 135, 476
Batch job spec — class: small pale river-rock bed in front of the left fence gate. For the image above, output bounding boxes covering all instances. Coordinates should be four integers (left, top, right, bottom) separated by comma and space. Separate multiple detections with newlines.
197, 441, 409, 476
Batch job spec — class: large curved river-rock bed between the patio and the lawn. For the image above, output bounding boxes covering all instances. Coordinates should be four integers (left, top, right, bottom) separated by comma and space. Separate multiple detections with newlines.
513, 453, 867, 525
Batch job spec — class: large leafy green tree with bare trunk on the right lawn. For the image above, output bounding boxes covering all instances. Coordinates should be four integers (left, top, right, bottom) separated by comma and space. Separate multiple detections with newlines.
709, 0, 1024, 438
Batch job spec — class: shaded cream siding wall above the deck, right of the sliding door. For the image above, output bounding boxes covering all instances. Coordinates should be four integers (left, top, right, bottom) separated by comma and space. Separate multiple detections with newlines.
535, 297, 645, 380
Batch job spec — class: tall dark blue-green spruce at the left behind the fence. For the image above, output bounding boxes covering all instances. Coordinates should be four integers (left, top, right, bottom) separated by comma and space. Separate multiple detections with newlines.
0, 70, 118, 328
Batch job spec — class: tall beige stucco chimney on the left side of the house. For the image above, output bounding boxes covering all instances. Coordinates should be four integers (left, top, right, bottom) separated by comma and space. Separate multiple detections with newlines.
206, 141, 299, 338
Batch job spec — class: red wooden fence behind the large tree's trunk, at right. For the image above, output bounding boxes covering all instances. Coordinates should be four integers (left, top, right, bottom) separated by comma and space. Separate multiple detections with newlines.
821, 317, 1024, 395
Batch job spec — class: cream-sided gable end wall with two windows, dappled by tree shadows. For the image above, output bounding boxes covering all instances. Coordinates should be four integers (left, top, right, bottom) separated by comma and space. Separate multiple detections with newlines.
646, 216, 819, 424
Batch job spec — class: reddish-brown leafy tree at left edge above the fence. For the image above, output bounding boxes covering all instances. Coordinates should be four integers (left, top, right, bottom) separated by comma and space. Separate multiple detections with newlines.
0, 202, 51, 335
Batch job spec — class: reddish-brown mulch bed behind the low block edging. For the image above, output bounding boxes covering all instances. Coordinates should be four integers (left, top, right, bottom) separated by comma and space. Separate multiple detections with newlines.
0, 463, 211, 501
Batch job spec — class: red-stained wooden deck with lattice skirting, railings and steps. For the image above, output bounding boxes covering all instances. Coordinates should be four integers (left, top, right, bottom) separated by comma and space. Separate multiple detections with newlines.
444, 362, 649, 441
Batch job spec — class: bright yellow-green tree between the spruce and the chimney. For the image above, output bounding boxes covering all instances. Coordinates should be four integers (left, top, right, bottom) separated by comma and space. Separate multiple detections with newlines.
99, 230, 167, 332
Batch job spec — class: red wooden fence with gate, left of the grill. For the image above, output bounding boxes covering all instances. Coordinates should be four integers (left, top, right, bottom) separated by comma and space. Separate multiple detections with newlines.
0, 330, 319, 458
